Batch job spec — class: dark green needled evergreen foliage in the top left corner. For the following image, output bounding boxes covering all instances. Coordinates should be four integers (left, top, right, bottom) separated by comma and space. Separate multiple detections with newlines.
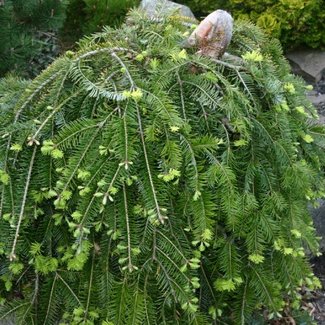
0, 0, 68, 77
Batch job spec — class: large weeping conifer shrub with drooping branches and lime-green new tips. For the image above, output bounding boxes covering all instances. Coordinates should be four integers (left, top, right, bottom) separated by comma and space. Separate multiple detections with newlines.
0, 11, 325, 325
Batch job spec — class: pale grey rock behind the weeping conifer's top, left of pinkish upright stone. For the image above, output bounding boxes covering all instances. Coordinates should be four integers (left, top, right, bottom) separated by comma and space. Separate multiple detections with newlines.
140, 0, 195, 19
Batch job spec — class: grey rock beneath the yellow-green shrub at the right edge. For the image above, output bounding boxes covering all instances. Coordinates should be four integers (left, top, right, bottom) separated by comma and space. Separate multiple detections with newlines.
287, 50, 325, 83
